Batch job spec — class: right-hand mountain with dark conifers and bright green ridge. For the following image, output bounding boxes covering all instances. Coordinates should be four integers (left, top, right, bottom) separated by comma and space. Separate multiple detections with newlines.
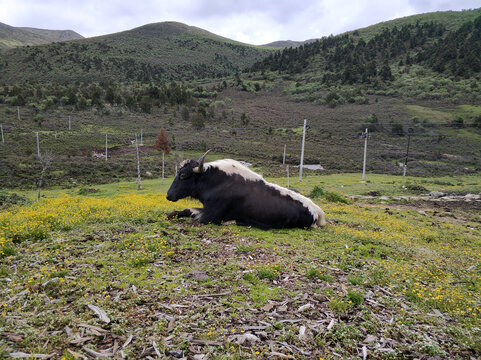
252, 9, 481, 98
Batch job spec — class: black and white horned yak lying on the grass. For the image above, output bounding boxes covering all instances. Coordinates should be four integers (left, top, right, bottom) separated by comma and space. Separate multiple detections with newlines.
167, 150, 326, 229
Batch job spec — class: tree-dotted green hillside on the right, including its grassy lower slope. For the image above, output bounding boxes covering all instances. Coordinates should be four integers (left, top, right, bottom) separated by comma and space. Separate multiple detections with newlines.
252, 9, 481, 106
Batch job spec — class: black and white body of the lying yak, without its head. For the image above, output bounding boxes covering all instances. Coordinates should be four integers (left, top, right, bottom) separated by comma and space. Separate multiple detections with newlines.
197, 159, 322, 229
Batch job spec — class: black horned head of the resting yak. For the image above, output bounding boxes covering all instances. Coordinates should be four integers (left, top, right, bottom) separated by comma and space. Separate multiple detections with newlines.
167, 150, 210, 201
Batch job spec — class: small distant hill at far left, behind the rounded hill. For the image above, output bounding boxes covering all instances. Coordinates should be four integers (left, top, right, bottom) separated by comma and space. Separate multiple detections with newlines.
0, 23, 83, 50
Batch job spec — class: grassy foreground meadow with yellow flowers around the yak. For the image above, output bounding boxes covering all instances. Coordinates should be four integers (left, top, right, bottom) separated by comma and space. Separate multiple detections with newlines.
0, 174, 481, 359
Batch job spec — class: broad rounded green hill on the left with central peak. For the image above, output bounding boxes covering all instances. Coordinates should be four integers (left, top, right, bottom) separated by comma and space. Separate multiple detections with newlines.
0, 22, 272, 82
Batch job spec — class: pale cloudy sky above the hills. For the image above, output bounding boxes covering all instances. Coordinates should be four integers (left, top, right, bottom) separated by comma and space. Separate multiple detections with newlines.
0, 0, 481, 45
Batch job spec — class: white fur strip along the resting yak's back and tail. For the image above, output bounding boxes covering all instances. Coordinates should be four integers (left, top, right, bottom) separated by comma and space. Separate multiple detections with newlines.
204, 159, 326, 226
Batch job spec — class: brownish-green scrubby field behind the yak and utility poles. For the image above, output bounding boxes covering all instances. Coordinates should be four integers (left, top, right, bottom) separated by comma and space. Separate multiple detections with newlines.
0, 78, 481, 188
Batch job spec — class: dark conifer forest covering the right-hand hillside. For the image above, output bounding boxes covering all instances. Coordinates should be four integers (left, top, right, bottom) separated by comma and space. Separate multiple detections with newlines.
251, 16, 481, 84
